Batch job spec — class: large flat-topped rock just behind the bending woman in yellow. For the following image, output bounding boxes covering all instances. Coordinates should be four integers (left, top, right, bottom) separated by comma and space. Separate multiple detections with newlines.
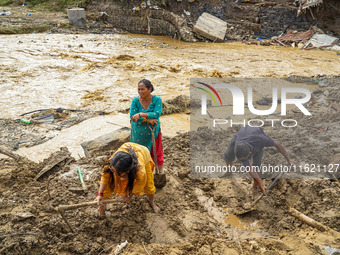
81, 127, 130, 157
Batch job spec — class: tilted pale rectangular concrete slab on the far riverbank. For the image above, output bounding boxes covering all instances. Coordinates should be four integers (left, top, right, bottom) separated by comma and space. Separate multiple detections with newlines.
193, 12, 227, 42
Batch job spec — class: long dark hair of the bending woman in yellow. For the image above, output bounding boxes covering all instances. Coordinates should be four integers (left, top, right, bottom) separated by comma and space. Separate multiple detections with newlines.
110, 147, 139, 193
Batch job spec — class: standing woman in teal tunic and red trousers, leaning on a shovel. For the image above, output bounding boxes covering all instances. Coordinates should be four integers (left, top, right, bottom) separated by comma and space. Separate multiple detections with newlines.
130, 79, 164, 173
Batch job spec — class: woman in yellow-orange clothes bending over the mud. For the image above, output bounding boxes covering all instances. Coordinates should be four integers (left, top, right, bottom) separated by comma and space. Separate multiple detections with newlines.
95, 142, 159, 216
